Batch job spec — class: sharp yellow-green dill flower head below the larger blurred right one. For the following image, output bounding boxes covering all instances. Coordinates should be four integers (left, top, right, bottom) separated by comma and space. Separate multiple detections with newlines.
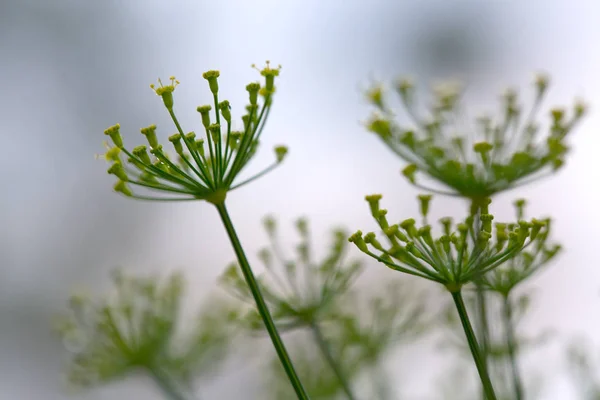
349, 195, 547, 293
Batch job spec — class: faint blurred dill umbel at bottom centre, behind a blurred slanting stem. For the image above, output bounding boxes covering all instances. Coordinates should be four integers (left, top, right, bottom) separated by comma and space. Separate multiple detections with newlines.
266, 280, 431, 400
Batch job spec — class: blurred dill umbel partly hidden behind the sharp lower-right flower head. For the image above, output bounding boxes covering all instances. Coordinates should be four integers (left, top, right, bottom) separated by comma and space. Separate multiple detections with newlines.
480, 199, 561, 297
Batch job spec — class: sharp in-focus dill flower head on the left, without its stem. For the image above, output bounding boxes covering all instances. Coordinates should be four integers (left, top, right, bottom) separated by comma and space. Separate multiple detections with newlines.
104, 62, 287, 204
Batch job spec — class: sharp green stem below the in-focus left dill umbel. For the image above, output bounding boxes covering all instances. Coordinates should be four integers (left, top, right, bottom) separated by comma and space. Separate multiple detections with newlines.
216, 202, 309, 400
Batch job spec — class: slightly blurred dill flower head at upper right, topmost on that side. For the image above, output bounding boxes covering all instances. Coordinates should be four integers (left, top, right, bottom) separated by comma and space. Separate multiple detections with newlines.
367, 75, 586, 198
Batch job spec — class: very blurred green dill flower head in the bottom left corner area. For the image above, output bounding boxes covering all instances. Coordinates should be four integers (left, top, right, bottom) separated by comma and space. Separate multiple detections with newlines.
55, 272, 236, 399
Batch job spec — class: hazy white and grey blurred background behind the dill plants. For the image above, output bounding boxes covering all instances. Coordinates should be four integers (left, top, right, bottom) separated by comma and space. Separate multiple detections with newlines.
0, 0, 600, 400
